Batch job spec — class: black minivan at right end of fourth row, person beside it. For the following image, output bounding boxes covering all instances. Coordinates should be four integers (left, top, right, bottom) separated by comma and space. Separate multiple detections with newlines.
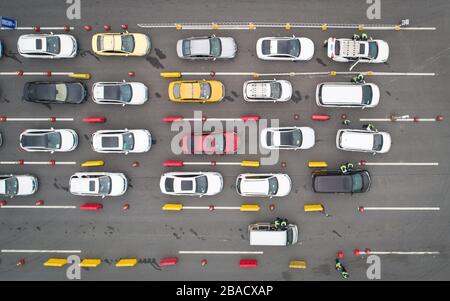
312, 170, 371, 193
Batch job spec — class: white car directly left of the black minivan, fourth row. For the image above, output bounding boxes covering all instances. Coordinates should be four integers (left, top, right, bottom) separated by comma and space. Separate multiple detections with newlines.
236, 173, 292, 197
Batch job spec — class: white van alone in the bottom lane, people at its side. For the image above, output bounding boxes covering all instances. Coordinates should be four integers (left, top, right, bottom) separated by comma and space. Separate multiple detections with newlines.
248, 223, 298, 246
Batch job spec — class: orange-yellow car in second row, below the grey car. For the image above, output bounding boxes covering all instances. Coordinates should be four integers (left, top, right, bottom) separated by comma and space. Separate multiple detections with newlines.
169, 80, 225, 102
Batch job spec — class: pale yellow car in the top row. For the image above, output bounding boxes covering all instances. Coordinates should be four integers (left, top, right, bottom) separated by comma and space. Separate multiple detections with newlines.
92, 32, 151, 56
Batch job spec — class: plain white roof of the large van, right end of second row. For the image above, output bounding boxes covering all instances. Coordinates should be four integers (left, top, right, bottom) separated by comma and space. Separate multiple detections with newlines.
321, 83, 363, 104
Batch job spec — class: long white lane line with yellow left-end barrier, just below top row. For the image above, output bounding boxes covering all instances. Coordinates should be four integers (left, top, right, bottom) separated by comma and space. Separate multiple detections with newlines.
160, 70, 436, 78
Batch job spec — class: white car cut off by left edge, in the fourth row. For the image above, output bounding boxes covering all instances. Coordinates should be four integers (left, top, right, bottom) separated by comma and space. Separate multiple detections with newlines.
0, 174, 38, 198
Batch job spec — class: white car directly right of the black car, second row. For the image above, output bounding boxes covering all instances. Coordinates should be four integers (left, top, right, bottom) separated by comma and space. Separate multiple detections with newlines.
92, 81, 148, 106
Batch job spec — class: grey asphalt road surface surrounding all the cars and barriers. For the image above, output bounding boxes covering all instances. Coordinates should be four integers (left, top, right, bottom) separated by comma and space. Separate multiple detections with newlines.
0, 0, 450, 280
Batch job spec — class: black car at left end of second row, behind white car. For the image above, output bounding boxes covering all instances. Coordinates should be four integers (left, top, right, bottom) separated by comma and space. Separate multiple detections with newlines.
23, 82, 87, 104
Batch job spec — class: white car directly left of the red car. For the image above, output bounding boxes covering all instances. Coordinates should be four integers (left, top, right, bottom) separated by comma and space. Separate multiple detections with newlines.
91, 129, 152, 154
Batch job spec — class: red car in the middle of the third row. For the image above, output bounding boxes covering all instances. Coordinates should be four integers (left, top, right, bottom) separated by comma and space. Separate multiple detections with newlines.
180, 132, 239, 155
